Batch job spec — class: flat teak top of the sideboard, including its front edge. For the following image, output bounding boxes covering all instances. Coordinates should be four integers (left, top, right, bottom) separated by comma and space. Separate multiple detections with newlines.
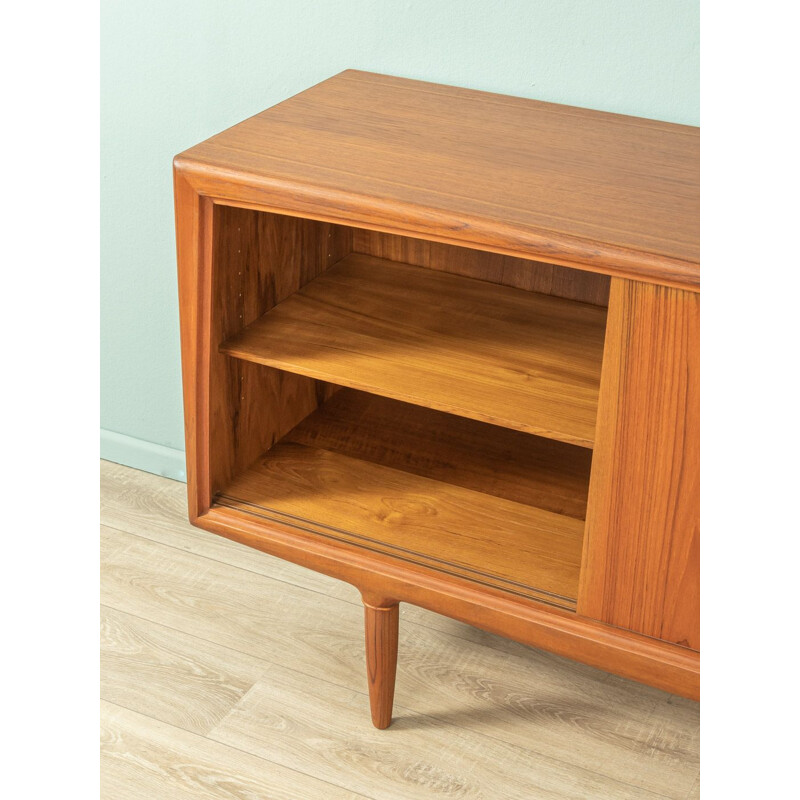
175, 70, 700, 289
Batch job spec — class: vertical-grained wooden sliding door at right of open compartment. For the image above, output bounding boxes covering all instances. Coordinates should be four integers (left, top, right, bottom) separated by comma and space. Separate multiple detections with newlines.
578, 278, 700, 649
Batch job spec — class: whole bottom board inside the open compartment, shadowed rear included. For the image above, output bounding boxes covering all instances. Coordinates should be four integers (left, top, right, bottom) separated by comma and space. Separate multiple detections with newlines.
215, 390, 590, 610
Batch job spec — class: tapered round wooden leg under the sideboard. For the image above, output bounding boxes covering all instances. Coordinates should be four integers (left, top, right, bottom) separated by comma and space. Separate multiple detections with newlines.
364, 602, 399, 730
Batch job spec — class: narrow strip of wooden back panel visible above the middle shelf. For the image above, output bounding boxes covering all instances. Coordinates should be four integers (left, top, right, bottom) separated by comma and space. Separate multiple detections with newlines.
353, 228, 610, 306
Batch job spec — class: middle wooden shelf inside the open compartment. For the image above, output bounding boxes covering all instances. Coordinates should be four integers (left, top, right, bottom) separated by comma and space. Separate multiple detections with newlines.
220, 254, 607, 447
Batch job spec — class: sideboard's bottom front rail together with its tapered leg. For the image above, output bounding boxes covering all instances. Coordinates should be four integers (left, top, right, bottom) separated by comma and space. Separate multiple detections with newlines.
200, 507, 700, 728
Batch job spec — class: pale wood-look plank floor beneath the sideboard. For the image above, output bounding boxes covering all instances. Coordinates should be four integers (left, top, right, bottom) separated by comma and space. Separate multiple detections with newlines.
101, 462, 700, 800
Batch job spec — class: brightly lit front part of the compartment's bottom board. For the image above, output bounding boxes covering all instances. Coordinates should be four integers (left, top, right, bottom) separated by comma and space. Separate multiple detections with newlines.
216, 442, 583, 608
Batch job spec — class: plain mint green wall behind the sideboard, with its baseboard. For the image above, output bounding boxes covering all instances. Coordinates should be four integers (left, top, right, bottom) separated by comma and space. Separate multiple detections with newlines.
101, 0, 699, 477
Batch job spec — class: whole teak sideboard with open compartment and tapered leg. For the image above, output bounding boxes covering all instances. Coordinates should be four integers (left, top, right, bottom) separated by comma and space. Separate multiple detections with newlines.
174, 70, 700, 728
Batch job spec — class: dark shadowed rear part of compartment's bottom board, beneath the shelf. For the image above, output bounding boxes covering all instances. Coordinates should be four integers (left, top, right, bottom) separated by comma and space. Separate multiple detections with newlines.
283, 389, 592, 519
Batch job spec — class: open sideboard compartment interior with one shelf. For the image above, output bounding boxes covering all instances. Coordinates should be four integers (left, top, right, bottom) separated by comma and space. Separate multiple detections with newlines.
210, 205, 609, 610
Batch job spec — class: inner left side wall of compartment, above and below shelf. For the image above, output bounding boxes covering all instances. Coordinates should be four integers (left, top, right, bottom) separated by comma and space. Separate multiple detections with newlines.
209, 205, 352, 495
